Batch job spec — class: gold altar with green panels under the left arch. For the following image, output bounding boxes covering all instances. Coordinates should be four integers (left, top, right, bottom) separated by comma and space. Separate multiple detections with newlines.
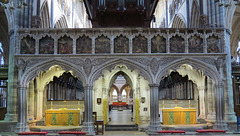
45, 109, 80, 126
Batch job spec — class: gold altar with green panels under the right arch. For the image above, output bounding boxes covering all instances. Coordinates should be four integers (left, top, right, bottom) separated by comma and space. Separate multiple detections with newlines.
162, 107, 197, 125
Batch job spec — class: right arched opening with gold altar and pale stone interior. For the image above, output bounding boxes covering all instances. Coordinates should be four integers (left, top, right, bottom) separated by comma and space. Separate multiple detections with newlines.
159, 64, 216, 125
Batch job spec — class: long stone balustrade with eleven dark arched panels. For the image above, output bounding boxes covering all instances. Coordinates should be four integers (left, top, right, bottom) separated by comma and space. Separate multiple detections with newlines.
15, 28, 226, 56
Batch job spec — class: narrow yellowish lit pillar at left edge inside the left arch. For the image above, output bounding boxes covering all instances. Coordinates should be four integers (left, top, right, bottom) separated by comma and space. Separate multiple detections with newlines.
27, 80, 34, 120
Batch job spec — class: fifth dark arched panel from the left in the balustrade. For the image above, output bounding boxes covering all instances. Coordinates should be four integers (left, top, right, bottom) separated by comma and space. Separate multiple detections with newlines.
95, 35, 110, 53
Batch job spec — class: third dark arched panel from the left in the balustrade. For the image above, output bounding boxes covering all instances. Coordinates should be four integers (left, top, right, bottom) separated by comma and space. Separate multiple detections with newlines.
58, 36, 73, 54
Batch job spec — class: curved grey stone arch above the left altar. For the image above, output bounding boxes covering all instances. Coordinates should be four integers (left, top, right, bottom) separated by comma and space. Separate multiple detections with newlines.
20, 59, 86, 86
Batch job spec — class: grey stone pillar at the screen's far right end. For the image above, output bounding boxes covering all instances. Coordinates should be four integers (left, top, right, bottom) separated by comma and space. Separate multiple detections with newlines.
213, 81, 227, 130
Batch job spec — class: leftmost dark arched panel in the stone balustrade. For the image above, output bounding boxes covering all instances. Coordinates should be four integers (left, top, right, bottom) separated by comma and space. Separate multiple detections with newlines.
20, 36, 35, 54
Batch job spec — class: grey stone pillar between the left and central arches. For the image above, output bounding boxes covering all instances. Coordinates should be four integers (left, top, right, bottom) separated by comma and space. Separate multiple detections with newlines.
82, 86, 95, 135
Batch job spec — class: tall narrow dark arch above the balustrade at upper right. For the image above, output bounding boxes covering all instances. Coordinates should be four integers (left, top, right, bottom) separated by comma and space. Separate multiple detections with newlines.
190, 0, 200, 28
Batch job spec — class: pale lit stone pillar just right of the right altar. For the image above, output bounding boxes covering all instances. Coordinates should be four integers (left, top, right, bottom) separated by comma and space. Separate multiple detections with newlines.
198, 86, 206, 119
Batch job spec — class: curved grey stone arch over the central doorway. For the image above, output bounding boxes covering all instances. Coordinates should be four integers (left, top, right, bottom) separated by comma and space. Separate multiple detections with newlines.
88, 59, 153, 83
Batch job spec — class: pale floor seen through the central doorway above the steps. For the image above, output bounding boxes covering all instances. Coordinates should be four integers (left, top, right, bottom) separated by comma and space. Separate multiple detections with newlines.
108, 110, 135, 125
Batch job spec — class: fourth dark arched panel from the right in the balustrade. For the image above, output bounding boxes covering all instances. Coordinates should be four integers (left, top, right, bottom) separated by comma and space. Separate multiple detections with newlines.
151, 35, 166, 53
